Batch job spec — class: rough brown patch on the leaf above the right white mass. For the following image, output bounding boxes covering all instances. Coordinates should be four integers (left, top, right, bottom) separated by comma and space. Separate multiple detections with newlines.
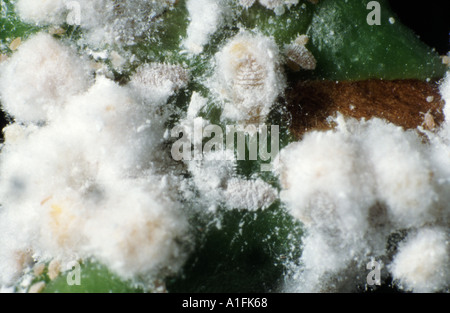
287, 80, 444, 139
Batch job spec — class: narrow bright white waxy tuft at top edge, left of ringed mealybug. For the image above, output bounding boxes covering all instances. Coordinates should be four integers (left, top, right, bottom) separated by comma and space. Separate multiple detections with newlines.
183, 0, 228, 54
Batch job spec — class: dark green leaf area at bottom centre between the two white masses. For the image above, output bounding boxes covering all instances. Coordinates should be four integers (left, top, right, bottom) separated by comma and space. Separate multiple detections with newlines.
167, 202, 302, 292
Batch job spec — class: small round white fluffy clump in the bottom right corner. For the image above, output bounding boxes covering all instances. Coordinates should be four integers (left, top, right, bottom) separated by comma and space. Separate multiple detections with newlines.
390, 228, 450, 292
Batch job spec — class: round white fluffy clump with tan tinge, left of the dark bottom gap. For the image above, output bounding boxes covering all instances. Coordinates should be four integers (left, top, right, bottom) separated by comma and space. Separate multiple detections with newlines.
86, 177, 187, 278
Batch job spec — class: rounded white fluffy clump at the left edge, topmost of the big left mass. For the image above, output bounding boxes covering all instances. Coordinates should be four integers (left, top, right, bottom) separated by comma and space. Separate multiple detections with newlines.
0, 33, 92, 121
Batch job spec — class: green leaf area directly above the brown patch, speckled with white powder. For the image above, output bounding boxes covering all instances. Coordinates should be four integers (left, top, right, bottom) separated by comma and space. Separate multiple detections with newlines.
307, 0, 446, 80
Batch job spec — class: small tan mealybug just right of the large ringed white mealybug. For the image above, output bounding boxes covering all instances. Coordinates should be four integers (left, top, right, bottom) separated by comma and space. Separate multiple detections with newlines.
285, 35, 317, 71
